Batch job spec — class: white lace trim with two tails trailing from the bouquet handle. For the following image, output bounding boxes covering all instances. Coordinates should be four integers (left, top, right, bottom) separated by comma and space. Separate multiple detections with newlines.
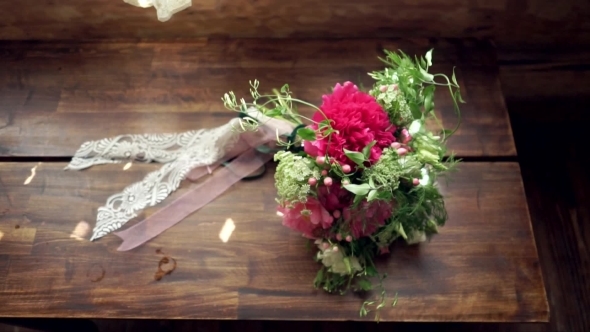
66, 120, 240, 240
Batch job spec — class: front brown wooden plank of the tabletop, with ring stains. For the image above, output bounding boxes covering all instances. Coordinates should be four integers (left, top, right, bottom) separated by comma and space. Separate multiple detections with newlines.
0, 163, 548, 322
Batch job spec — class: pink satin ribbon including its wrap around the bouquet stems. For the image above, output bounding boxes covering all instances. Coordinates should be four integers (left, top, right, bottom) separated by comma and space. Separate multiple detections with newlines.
114, 119, 292, 251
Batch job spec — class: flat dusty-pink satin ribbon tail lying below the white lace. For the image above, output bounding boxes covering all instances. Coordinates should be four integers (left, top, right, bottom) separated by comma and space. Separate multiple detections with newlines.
114, 149, 272, 251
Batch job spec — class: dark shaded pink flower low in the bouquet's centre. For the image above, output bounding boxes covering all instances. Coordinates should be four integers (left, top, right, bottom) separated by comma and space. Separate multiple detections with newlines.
343, 201, 393, 239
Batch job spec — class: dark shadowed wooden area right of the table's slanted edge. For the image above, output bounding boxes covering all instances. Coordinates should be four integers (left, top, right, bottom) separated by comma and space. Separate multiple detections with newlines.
509, 101, 590, 332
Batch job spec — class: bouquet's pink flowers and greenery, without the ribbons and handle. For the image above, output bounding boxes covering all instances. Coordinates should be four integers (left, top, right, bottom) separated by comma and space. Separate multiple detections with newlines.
223, 50, 463, 293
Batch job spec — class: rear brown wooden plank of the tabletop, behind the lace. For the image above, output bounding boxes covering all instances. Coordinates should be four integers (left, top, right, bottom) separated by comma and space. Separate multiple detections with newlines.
0, 40, 516, 157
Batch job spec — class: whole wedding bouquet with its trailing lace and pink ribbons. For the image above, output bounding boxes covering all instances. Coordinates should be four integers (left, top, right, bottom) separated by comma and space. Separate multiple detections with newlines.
67, 51, 463, 314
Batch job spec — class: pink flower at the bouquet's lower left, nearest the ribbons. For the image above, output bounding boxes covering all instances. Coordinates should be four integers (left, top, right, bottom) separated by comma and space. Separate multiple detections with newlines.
278, 197, 334, 239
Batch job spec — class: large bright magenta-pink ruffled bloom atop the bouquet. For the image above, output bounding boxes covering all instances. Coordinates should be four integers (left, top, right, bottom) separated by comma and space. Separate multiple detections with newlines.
304, 82, 396, 164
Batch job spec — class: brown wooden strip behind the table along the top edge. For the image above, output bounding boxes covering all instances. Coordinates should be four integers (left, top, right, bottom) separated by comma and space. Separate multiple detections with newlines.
0, 0, 590, 46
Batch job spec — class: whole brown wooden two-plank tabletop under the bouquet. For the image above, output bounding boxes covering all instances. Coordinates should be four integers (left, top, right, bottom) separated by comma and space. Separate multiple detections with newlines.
0, 40, 548, 322
